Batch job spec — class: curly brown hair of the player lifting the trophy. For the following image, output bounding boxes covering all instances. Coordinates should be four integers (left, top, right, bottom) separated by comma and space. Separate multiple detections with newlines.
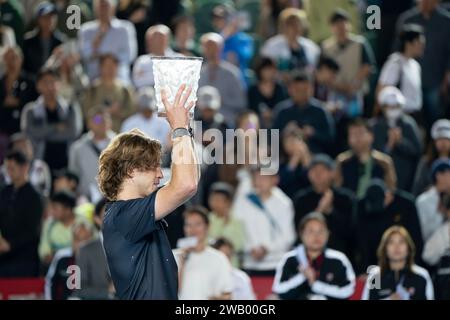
97, 129, 161, 201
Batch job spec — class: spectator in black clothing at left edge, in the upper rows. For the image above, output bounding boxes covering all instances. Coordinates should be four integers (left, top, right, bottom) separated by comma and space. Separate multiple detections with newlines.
0, 47, 37, 135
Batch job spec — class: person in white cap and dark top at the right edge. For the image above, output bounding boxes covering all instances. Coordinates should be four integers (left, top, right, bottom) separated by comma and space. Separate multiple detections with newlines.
412, 119, 450, 196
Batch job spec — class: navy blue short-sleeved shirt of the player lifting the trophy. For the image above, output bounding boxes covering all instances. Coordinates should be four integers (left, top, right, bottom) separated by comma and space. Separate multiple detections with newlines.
103, 191, 178, 300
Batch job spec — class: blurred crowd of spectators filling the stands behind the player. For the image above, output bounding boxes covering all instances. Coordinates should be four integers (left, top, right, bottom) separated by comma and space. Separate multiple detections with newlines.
0, 0, 450, 299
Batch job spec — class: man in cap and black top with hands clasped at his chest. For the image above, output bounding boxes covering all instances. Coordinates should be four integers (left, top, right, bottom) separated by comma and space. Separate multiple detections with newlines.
294, 154, 355, 257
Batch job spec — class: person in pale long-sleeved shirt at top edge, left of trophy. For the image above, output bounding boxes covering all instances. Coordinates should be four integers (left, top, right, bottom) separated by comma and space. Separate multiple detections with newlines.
78, 0, 137, 84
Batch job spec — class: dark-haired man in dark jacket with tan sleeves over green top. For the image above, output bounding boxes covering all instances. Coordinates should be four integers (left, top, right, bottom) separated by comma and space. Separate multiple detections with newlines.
336, 119, 397, 199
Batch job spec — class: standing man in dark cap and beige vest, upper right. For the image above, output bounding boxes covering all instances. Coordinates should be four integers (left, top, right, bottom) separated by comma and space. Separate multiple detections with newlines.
322, 8, 376, 121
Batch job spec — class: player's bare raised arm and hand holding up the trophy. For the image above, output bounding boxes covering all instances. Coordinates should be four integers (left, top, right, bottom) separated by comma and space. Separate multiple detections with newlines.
155, 85, 200, 220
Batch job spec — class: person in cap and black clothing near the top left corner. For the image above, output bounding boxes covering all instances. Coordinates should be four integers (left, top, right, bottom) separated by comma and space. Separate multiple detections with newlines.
23, 1, 66, 75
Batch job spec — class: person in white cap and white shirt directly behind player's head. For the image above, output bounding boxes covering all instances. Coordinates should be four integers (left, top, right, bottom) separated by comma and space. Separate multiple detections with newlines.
120, 87, 170, 149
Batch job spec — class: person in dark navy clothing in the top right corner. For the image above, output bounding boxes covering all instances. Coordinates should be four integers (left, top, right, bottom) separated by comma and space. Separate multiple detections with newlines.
396, 0, 450, 129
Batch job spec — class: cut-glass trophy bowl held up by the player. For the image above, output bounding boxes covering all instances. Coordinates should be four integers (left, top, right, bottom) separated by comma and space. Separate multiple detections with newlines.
151, 56, 203, 119
